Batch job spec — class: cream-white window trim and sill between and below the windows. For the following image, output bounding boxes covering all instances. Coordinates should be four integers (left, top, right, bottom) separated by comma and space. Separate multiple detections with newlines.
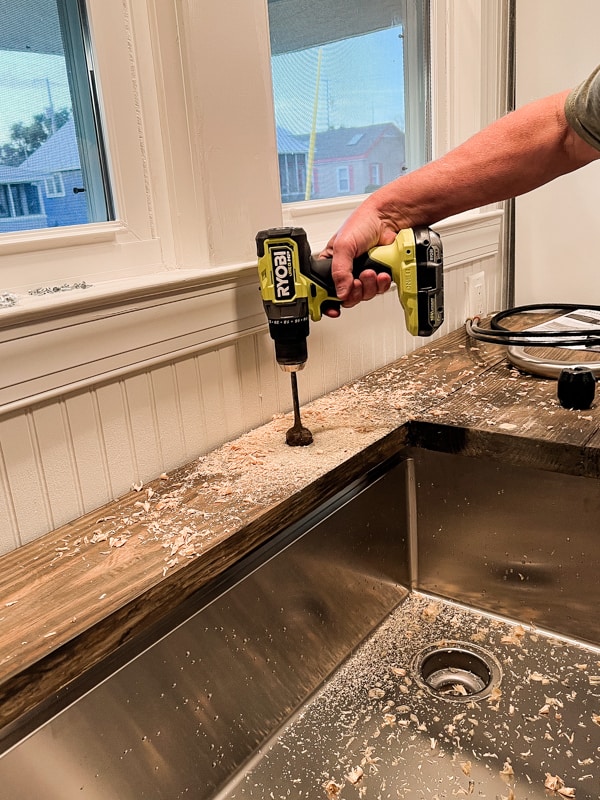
0, 0, 503, 412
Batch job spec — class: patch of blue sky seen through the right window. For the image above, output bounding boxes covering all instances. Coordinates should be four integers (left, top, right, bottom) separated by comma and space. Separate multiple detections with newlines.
272, 27, 404, 134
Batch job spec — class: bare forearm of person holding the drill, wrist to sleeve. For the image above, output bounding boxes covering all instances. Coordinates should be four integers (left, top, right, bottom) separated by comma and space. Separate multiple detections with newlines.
365, 92, 600, 229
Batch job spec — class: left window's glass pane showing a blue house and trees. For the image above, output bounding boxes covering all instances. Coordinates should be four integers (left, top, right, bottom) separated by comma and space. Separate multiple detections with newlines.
0, 0, 112, 233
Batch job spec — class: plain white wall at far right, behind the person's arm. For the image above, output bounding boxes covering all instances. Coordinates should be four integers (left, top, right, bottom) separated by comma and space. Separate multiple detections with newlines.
515, 0, 600, 305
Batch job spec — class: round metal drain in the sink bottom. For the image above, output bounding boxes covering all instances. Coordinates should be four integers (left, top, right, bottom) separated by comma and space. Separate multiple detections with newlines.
413, 641, 502, 700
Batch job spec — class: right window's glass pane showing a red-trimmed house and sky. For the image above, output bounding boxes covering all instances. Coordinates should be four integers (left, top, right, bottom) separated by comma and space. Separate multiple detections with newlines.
269, 0, 428, 203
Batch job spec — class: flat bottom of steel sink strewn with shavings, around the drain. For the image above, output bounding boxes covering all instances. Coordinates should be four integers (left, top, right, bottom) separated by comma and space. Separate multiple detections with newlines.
220, 592, 600, 800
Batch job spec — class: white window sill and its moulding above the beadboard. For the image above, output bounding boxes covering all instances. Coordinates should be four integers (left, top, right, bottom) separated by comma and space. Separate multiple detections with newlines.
0, 209, 502, 414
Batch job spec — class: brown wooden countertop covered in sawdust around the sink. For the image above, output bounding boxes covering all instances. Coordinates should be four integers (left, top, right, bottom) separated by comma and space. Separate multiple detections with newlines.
0, 330, 600, 738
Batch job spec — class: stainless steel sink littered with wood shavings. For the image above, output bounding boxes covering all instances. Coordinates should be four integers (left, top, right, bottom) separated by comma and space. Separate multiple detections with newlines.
0, 448, 600, 800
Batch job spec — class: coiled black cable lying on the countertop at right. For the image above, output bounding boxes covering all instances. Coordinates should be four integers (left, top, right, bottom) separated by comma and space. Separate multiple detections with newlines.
466, 303, 600, 347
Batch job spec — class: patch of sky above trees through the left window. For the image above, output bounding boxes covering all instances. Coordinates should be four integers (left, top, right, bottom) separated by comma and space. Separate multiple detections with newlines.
0, 50, 71, 144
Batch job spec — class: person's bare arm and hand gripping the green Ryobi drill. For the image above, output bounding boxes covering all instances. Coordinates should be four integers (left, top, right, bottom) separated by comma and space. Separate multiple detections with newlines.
321, 91, 600, 308
